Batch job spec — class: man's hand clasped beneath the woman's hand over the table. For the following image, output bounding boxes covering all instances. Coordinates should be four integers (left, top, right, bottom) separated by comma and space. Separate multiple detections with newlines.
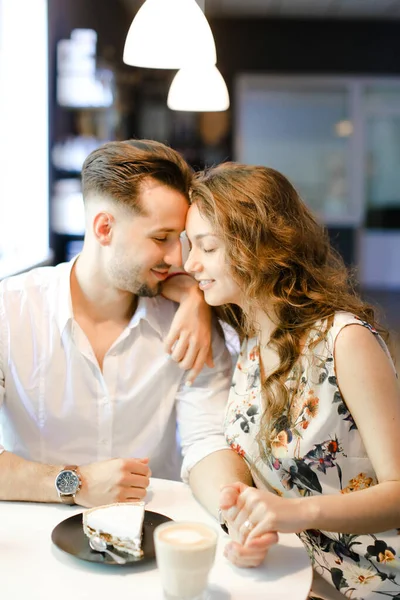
220, 483, 279, 567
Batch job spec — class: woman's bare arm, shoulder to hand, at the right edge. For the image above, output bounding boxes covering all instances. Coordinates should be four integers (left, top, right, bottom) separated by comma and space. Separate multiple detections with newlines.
222, 325, 400, 540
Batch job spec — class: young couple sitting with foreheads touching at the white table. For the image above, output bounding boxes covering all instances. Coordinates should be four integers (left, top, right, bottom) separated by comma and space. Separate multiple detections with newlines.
0, 141, 400, 599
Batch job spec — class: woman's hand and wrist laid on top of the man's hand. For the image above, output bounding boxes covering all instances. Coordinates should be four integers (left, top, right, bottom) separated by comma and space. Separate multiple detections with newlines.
220, 483, 307, 544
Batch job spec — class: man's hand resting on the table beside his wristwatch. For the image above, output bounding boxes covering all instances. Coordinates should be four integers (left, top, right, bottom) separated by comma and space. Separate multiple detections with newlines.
76, 458, 151, 507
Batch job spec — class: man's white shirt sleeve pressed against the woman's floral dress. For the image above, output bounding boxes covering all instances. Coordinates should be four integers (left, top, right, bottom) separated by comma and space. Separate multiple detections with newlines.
176, 318, 232, 482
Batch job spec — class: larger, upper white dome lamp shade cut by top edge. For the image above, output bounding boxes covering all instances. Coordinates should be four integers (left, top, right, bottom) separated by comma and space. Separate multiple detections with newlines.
123, 0, 217, 69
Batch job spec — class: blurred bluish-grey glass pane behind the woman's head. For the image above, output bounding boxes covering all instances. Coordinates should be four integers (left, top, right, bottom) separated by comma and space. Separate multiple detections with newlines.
236, 75, 362, 226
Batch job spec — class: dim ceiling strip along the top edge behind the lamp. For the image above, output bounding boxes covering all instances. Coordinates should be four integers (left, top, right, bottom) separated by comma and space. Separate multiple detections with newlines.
121, 0, 400, 19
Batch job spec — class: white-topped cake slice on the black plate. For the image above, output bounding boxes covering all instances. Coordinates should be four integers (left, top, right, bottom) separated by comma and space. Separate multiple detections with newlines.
82, 502, 145, 558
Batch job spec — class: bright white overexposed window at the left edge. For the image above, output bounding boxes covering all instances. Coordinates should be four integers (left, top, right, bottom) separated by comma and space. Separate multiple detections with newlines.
0, 0, 50, 277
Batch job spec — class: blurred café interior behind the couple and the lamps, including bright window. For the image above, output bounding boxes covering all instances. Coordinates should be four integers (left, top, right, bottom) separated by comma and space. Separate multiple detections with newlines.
0, 0, 400, 354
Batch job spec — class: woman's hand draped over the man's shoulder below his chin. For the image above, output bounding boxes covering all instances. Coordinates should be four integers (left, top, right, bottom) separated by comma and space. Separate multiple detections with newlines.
163, 275, 214, 385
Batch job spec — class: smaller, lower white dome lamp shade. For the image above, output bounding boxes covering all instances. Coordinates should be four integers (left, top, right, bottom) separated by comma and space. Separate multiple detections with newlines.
167, 65, 229, 112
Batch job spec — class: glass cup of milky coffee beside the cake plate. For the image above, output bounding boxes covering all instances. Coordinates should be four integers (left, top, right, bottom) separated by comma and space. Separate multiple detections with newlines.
154, 521, 218, 600
